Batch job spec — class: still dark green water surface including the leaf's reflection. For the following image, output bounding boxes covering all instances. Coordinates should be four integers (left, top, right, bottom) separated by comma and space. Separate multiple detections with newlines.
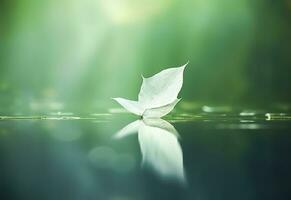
0, 108, 291, 200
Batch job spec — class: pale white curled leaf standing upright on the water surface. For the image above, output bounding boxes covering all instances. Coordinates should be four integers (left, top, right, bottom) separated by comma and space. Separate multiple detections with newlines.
113, 63, 188, 118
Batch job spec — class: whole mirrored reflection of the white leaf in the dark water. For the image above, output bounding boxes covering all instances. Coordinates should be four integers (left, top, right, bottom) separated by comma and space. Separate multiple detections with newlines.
114, 119, 185, 183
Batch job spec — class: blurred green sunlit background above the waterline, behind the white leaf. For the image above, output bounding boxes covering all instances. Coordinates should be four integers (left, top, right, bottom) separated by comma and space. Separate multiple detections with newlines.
0, 0, 291, 114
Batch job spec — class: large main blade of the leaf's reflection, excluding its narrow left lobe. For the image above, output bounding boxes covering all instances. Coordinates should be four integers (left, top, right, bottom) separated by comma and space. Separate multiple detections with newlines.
138, 124, 185, 182
